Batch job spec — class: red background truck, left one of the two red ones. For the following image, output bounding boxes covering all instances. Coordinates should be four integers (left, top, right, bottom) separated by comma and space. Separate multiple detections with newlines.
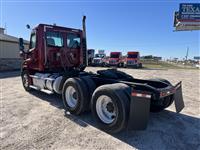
108, 52, 124, 67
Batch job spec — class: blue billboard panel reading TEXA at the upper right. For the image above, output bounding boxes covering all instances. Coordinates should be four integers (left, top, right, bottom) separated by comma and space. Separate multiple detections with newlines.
179, 3, 200, 21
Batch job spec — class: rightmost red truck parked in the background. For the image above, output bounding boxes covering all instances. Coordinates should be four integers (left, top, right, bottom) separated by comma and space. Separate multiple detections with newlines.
124, 51, 142, 68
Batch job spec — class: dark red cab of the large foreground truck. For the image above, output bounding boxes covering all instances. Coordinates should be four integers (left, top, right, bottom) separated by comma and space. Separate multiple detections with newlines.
20, 24, 86, 72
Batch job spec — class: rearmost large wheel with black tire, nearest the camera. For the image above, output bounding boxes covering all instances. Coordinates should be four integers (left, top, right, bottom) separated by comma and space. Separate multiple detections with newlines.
91, 83, 130, 133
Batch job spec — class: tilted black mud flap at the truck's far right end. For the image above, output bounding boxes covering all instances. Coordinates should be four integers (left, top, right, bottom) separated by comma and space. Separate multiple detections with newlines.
174, 82, 185, 113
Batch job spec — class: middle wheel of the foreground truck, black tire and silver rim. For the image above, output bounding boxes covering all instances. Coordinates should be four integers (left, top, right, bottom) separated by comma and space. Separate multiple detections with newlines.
62, 78, 89, 115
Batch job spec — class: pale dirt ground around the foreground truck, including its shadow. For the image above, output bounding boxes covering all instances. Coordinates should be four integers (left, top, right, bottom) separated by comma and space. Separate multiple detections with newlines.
0, 67, 200, 150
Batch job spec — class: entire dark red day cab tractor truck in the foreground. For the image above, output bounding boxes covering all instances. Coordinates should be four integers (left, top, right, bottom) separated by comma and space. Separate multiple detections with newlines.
19, 16, 184, 133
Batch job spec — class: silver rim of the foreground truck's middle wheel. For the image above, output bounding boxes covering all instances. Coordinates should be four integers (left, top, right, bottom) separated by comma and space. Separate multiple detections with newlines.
65, 86, 78, 108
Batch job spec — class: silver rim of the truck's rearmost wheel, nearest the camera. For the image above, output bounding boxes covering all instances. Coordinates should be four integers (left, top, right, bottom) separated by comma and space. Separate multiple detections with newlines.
96, 95, 116, 124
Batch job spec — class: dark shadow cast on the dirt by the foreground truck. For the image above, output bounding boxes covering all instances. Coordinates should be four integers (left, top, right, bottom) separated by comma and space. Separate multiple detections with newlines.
28, 91, 200, 150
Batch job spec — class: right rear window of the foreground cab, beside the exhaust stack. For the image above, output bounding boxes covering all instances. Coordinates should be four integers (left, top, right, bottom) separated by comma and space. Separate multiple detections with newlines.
67, 33, 81, 48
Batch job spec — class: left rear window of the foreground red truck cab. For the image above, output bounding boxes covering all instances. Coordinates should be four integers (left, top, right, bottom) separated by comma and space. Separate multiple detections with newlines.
46, 32, 63, 47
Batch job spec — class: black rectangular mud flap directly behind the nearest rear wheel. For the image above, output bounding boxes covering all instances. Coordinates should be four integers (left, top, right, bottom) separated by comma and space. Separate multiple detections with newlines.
127, 96, 151, 130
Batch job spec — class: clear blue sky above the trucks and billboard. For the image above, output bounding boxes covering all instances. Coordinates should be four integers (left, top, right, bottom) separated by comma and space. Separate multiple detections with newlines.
0, 0, 200, 58
